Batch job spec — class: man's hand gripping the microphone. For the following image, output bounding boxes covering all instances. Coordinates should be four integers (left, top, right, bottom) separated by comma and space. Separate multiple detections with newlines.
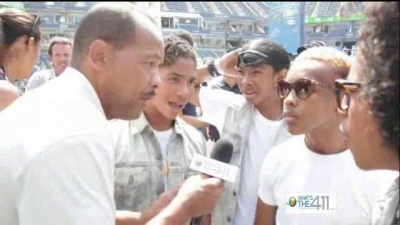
171, 175, 224, 218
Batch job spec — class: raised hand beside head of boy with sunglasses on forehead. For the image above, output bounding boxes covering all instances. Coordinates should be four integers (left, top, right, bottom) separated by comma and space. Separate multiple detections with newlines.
214, 48, 241, 77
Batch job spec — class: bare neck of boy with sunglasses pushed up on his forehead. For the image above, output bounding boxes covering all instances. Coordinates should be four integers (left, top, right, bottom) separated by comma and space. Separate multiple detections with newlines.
254, 95, 283, 121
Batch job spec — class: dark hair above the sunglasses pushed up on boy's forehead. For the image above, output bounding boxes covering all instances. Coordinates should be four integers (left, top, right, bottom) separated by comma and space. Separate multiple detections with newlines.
241, 39, 290, 72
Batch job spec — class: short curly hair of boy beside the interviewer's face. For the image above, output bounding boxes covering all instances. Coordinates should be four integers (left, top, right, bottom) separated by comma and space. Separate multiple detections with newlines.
160, 35, 197, 66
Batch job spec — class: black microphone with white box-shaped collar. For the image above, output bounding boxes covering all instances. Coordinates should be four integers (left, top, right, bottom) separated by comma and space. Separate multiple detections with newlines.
190, 139, 239, 225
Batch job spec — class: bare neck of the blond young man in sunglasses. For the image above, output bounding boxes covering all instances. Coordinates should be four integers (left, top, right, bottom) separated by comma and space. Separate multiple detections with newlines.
304, 121, 347, 155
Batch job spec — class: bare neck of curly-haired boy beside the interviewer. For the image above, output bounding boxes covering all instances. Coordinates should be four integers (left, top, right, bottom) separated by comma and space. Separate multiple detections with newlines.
144, 103, 174, 131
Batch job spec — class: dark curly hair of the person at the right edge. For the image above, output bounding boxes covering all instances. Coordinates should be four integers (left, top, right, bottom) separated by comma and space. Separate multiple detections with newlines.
357, 2, 400, 152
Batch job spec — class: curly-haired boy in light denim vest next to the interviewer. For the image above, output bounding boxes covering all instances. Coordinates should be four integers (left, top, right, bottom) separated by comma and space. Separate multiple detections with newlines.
111, 36, 206, 224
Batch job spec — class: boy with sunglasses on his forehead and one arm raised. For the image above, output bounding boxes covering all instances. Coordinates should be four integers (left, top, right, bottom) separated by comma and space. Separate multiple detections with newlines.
189, 39, 290, 225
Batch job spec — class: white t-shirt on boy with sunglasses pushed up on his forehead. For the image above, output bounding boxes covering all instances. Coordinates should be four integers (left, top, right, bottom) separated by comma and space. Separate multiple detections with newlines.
200, 88, 283, 225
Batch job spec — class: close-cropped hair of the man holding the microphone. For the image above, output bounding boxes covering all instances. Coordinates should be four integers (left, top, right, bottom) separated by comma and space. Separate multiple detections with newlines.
71, 3, 161, 67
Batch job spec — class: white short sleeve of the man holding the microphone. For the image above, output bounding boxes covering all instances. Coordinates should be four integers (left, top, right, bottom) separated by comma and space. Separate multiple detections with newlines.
17, 135, 115, 225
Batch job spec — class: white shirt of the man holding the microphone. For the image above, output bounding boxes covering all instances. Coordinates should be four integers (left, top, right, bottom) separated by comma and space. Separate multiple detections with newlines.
0, 68, 115, 225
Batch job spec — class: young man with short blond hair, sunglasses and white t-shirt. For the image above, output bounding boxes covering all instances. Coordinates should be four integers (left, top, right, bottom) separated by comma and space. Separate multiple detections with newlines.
256, 47, 391, 225
